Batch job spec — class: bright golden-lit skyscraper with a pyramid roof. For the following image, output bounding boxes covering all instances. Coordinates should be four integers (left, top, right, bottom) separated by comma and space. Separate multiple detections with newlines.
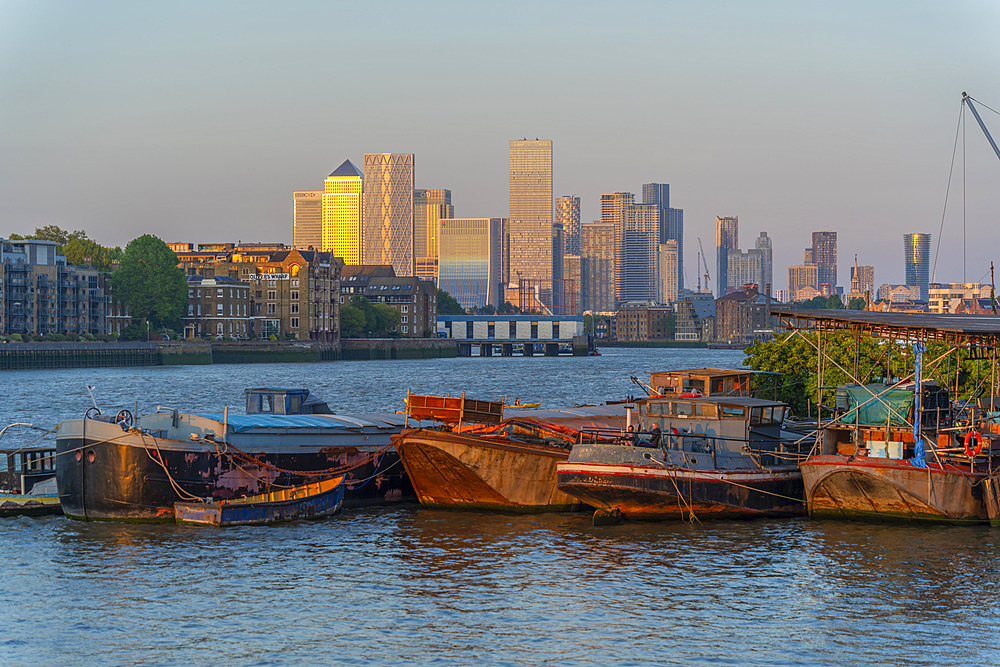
320, 160, 364, 266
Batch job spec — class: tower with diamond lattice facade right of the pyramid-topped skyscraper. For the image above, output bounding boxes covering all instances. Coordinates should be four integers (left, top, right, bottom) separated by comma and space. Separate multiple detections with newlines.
361, 153, 416, 276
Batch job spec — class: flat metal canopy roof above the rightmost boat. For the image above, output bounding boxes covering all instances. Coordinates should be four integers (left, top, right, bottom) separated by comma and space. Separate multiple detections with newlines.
770, 308, 1000, 347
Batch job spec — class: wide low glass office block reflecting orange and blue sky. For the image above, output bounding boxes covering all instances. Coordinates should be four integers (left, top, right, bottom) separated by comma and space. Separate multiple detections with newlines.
438, 218, 503, 309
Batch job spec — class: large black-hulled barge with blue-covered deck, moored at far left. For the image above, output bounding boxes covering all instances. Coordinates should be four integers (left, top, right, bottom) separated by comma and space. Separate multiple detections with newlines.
56, 389, 413, 522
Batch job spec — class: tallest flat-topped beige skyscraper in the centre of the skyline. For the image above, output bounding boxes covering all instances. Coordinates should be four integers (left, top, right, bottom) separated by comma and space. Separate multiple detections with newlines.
510, 139, 553, 290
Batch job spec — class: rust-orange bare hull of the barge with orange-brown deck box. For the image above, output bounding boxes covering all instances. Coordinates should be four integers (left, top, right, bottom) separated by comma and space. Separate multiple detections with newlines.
394, 429, 581, 513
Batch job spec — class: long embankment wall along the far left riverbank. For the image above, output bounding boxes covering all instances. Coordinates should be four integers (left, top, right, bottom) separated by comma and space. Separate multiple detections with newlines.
0, 338, 458, 370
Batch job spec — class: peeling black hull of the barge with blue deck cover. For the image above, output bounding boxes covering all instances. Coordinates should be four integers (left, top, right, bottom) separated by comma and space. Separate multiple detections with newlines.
56, 420, 414, 522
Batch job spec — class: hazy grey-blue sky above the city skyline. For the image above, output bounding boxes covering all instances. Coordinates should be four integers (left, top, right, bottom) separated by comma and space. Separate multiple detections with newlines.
0, 0, 1000, 288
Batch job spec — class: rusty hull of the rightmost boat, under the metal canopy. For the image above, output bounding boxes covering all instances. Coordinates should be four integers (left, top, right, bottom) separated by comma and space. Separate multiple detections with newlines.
802, 455, 989, 524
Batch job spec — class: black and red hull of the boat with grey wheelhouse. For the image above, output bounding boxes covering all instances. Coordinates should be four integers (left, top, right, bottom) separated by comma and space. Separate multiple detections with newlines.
558, 461, 805, 521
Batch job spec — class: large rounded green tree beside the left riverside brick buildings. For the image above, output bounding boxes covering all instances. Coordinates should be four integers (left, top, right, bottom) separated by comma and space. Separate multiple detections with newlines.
111, 234, 187, 328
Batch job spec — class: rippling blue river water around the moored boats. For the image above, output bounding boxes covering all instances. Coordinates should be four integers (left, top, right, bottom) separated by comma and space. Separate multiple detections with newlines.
0, 349, 1000, 665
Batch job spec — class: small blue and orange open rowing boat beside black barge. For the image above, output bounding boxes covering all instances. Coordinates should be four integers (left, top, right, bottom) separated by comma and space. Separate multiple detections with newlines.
174, 476, 344, 526
